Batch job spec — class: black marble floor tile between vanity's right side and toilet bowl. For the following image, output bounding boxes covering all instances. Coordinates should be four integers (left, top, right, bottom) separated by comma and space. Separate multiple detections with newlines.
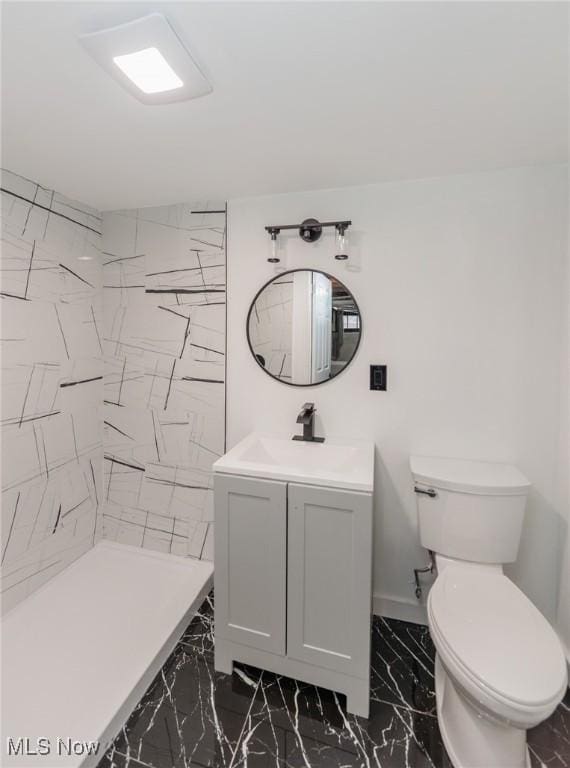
370, 616, 436, 716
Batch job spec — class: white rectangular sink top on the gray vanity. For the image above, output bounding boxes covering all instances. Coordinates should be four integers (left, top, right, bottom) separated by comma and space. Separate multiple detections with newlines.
214, 432, 374, 492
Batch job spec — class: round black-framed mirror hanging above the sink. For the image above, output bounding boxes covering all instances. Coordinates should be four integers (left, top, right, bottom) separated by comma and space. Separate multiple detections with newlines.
247, 269, 362, 387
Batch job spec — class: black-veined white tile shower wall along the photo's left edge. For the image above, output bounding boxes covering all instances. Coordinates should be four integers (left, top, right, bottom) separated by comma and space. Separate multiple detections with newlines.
0, 171, 103, 611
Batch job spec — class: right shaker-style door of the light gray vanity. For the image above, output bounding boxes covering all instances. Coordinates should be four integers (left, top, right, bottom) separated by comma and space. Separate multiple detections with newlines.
287, 484, 372, 677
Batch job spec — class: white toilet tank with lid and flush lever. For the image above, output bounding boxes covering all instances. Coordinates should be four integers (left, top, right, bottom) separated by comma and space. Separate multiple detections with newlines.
410, 456, 530, 563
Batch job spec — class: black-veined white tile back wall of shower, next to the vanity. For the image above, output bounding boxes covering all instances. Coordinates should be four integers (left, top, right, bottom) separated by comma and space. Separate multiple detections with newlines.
98, 203, 226, 559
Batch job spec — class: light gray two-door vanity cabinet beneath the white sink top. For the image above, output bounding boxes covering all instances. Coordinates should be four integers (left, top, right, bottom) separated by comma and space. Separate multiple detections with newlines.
214, 472, 372, 717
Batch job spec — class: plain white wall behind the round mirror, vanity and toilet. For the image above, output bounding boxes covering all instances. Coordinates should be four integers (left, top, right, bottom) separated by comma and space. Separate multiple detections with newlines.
228, 167, 567, 619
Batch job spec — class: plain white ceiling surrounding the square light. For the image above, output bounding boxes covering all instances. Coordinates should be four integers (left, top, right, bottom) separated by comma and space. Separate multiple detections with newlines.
2, 0, 568, 210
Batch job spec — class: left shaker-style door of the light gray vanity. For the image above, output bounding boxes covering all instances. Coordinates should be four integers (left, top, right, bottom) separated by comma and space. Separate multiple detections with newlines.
214, 474, 287, 655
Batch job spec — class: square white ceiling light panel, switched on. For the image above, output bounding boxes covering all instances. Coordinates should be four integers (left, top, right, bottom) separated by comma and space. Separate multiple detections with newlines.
79, 13, 212, 104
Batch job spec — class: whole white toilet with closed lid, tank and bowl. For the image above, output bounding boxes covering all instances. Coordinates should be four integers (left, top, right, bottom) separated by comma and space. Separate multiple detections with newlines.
410, 456, 568, 768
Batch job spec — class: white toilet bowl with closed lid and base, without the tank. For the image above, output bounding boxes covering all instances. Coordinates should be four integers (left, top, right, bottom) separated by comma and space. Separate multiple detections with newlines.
428, 556, 567, 768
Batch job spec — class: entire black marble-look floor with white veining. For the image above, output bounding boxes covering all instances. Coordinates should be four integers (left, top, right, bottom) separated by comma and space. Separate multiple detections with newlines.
98, 595, 570, 768
